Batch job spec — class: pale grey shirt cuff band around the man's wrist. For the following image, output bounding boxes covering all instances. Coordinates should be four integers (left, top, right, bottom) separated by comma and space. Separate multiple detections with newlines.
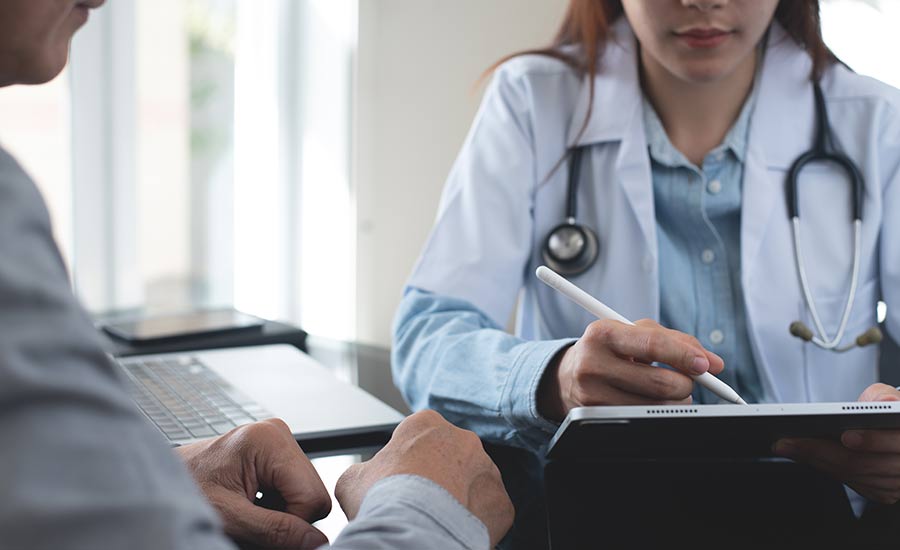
357, 474, 491, 550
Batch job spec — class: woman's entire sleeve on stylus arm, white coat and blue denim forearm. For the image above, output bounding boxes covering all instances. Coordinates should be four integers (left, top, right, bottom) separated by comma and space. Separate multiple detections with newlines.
392, 60, 571, 450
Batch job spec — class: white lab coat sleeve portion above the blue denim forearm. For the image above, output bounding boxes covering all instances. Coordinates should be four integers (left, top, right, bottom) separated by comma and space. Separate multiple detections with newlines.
408, 63, 537, 327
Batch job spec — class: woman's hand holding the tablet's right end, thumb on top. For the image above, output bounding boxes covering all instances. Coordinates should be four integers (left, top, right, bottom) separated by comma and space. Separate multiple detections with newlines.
775, 384, 900, 504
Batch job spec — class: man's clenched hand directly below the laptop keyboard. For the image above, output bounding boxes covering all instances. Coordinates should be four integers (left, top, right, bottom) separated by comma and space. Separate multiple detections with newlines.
176, 419, 331, 549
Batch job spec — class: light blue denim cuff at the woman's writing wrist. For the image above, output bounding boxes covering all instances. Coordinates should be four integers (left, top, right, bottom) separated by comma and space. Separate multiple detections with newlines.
500, 338, 576, 448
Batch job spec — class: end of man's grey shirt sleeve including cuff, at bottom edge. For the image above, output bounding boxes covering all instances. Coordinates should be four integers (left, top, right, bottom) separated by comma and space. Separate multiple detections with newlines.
323, 475, 490, 550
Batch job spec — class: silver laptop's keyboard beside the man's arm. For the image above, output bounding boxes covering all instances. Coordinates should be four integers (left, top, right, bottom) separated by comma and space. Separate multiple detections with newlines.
116, 355, 272, 442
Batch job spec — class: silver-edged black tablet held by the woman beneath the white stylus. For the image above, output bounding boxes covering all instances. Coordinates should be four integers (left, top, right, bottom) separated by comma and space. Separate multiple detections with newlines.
547, 402, 900, 460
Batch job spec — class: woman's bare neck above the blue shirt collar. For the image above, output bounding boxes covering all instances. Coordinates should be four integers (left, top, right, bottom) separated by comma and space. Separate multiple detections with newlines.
641, 50, 759, 166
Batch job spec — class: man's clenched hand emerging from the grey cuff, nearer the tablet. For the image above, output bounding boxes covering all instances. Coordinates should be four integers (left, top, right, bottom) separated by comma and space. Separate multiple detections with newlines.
335, 411, 515, 547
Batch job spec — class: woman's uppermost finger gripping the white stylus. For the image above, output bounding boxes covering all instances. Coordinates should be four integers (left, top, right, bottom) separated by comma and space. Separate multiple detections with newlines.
585, 321, 710, 375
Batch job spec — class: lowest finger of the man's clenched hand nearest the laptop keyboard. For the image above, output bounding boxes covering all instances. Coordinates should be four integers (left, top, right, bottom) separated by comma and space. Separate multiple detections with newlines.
216, 493, 328, 550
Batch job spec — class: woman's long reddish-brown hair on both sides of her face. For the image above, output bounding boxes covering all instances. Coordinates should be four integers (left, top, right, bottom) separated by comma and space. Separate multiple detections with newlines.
488, 0, 837, 144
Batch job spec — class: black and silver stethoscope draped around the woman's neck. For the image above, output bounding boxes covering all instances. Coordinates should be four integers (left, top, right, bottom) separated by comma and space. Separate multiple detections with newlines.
542, 82, 882, 352
